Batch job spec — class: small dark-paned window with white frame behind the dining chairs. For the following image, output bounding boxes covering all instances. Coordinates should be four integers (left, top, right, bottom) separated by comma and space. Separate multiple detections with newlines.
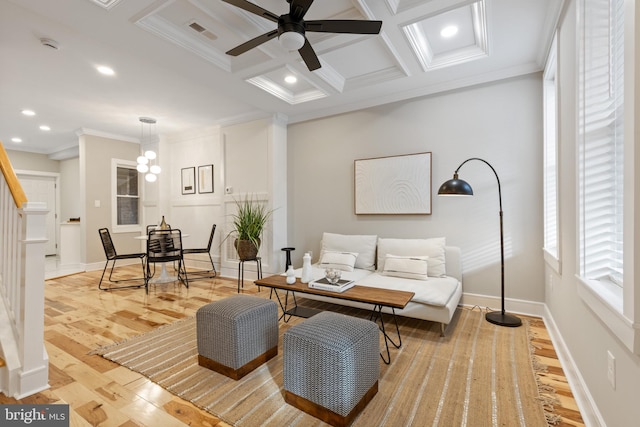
112, 159, 140, 232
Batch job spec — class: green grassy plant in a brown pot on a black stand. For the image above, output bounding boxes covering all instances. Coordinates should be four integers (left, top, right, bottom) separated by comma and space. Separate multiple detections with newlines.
229, 196, 273, 261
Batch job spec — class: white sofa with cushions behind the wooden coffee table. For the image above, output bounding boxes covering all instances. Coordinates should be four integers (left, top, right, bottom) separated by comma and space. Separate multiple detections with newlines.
296, 233, 462, 335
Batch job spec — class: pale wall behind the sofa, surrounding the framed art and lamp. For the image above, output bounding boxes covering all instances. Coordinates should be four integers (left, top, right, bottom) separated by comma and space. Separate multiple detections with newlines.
288, 74, 544, 308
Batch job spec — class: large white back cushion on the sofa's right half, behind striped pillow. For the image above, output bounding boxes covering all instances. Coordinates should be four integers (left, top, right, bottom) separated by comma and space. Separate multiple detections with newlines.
378, 237, 446, 277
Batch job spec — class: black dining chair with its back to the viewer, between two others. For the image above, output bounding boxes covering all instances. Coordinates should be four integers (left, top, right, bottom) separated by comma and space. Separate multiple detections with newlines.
145, 228, 189, 293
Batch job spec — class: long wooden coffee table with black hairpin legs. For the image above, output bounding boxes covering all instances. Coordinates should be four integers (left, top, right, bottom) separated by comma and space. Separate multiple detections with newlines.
254, 275, 415, 364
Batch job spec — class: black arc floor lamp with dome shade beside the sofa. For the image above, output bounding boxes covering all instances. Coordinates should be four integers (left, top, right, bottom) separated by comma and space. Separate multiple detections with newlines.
438, 157, 522, 327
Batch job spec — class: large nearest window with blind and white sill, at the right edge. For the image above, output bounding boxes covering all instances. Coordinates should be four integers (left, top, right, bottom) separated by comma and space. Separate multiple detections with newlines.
577, 0, 640, 354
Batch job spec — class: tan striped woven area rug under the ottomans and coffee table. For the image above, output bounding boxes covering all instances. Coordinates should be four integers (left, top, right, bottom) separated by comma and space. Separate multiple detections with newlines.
94, 303, 554, 427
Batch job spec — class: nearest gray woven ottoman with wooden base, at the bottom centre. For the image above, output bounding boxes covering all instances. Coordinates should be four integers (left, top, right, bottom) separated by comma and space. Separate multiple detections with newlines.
283, 311, 380, 426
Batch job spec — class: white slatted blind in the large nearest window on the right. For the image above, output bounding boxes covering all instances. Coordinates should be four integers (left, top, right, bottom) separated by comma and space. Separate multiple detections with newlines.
579, 0, 624, 285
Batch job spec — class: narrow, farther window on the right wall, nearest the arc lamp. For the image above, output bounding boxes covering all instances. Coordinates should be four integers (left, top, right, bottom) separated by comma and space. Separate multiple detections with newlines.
543, 33, 560, 273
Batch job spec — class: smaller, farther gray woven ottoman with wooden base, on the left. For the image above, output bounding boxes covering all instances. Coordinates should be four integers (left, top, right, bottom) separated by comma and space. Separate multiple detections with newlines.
196, 295, 278, 380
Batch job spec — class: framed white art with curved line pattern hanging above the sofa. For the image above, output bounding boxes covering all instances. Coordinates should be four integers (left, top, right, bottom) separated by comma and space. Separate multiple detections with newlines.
354, 152, 431, 215
